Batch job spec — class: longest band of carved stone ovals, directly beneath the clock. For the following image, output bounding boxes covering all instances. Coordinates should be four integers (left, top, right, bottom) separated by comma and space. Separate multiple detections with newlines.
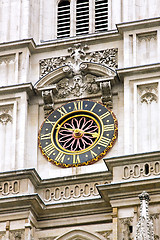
44, 182, 103, 202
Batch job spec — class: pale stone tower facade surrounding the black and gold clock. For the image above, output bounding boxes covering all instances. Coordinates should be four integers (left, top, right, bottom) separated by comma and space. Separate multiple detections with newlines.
0, 0, 160, 240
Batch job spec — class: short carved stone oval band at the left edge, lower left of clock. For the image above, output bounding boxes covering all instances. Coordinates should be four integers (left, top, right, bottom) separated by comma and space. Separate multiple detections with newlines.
0, 180, 20, 196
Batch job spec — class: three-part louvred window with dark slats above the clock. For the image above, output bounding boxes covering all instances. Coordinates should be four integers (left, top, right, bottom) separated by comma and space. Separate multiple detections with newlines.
57, 0, 108, 38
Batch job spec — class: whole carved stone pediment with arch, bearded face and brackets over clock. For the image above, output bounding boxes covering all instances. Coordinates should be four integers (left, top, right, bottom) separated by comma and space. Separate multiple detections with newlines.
35, 44, 118, 114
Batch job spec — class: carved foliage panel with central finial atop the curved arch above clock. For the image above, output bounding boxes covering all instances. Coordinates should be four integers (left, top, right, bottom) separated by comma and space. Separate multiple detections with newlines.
39, 43, 118, 78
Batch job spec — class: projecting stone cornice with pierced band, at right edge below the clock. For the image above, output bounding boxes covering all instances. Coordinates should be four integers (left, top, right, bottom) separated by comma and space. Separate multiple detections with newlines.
97, 151, 160, 207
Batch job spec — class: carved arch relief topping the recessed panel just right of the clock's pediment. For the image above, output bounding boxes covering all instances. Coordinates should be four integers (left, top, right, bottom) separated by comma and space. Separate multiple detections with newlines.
138, 83, 158, 104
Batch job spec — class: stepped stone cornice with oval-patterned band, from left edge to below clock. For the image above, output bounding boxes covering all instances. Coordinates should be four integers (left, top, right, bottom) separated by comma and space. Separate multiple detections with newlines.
0, 169, 111, 220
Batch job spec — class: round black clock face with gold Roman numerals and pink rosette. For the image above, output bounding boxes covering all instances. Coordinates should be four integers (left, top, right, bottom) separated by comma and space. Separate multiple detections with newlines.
38, 100, 118, 167
